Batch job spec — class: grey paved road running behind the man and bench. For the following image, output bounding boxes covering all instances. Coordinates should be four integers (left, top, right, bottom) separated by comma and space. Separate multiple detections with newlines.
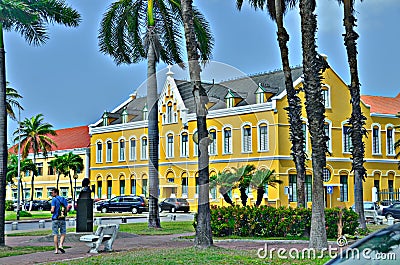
5, 212, 194, 232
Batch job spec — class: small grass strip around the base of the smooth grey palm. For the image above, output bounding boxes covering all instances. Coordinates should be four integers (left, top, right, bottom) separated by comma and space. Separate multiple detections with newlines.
119, 222, 194, 235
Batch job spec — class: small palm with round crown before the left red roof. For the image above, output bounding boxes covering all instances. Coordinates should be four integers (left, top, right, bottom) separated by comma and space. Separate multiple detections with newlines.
14, 114, 57, 210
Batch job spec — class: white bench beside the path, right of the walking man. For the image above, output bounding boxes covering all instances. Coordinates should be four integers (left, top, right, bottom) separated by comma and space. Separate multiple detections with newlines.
79, 224, 119, 253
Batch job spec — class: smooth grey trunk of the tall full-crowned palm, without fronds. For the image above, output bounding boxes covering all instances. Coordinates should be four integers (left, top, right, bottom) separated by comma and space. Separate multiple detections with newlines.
147, 31, 161, 228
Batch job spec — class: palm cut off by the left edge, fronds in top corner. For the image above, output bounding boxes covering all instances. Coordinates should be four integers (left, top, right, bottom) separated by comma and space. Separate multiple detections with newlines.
0, 0, 80, 246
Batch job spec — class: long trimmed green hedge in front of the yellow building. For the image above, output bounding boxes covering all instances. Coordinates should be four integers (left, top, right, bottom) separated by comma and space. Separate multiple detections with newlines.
193, 205, 358, 238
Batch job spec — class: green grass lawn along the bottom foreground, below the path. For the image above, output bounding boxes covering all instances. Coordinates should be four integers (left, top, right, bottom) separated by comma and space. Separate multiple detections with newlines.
53, 247, 329, 265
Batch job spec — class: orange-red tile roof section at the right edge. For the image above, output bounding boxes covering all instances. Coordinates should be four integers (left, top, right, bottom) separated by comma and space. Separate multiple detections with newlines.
361, 93, 400, 114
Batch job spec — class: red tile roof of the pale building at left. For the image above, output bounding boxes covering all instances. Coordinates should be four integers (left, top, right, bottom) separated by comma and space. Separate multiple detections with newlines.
9, 125, 90, 153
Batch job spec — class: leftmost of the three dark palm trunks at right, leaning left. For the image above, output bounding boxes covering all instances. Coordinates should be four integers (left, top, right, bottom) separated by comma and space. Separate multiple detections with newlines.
275, 0, 307, 207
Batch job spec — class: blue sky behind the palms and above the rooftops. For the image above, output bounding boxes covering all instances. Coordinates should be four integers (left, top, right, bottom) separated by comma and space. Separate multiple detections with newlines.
5, 0, 400, 142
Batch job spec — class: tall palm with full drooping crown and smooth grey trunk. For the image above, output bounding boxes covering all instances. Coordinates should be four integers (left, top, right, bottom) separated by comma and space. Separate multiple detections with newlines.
99, 0, 212, 228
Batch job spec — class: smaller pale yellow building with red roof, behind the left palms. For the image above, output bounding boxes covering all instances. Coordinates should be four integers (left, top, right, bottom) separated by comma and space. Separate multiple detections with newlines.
6, 126, 90, 200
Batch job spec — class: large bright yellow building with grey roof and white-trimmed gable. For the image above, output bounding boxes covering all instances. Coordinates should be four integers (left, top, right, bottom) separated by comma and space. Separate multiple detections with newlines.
89, 58, 400, 210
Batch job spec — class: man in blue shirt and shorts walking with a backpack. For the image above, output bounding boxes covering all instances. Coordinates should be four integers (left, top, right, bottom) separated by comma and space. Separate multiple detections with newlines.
51, 189, 68, 254
